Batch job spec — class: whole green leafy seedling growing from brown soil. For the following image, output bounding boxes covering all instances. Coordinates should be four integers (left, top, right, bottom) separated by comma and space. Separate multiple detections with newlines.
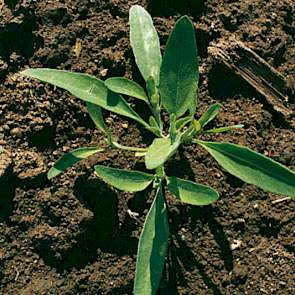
22, 5, 295, 295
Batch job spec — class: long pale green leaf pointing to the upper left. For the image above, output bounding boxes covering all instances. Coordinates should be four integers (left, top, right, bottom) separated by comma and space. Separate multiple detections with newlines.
21, 69, 148, 126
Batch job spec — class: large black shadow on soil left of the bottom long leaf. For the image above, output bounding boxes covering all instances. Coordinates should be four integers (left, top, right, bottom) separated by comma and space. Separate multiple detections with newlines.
34, 174, 142, 272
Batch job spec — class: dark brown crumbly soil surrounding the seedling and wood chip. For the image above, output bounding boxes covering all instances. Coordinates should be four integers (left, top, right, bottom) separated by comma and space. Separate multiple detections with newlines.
0, 0, 295, 295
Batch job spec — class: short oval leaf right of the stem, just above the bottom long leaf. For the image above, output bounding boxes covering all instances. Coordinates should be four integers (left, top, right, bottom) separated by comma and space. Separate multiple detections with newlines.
168, 177, 219, 205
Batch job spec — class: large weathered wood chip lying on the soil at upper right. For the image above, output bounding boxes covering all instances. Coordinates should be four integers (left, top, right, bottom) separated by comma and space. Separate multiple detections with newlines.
208, 37, 294, 125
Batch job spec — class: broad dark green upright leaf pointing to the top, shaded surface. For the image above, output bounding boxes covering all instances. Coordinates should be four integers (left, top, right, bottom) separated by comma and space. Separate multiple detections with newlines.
160, 16, 199, 117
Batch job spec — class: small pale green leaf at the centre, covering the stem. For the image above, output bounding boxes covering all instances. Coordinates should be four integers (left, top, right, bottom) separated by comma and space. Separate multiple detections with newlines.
145, 138, 180, 169
